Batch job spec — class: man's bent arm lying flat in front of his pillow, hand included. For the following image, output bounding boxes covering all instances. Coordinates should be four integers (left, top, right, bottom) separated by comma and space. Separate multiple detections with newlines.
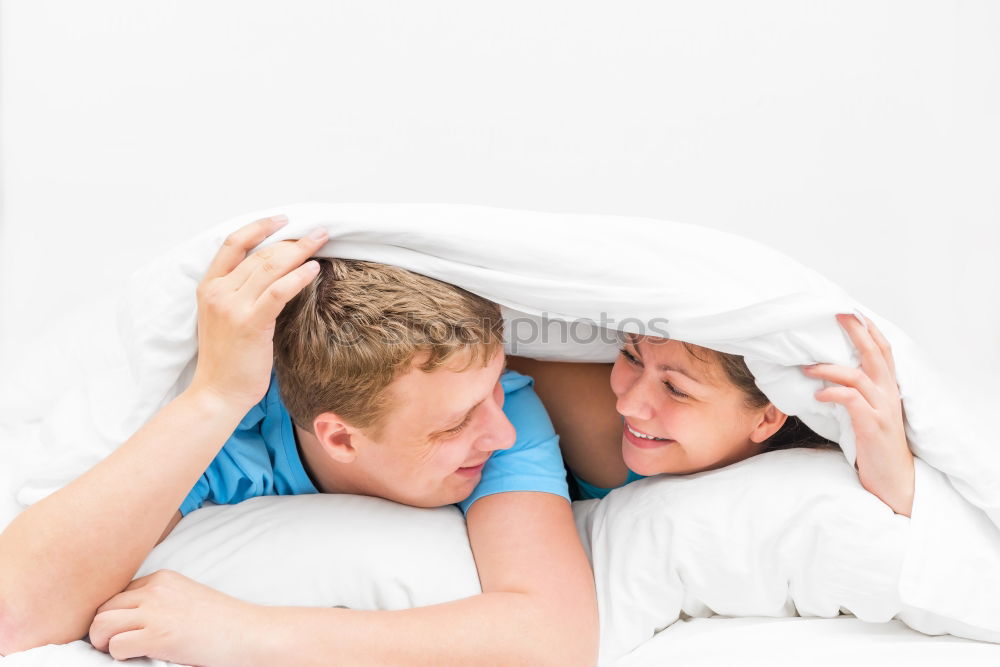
91, 492, 598, 667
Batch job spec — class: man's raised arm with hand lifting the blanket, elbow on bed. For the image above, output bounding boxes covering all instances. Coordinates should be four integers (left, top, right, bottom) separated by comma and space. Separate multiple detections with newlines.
0, 219, 325, 655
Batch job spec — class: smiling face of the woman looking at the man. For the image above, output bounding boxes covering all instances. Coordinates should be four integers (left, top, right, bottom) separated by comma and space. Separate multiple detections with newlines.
611, 334, 783, 475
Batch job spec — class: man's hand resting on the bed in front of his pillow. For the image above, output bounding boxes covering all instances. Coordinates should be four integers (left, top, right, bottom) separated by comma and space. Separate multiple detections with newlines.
89, 570, 257, 667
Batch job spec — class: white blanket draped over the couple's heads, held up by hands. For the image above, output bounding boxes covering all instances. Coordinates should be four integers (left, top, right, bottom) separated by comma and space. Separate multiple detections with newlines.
9, 203, 1000, 631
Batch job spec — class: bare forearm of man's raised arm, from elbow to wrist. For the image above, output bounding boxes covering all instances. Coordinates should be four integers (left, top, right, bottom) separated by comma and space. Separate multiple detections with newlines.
0, 394, 243, 652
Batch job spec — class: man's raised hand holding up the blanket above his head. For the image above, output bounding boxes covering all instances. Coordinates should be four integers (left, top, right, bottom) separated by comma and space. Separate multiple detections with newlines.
191, 216, 328, 410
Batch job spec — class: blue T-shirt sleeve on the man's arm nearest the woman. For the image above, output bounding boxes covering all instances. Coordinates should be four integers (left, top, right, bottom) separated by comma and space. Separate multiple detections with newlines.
458, 371, 569, 512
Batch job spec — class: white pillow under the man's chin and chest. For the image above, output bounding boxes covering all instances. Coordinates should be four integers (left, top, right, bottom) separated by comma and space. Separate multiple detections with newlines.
136, 494, 481, 609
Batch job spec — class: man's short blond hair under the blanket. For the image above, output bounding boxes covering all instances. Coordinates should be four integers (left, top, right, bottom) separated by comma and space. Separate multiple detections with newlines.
274, 258, 503, 438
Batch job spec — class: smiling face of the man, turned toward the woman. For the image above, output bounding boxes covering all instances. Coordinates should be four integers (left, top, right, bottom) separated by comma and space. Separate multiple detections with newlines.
352, 350, 515, 507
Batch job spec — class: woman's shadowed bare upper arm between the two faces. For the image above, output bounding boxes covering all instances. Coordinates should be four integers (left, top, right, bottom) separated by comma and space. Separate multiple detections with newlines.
507, 357, 628, 488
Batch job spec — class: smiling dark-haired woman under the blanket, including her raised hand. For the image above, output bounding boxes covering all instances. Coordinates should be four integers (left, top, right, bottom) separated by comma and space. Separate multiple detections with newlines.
508, 315, 913, 516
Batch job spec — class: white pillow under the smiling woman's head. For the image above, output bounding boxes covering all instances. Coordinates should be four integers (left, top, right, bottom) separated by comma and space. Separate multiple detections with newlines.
580, 449, 909, 662
